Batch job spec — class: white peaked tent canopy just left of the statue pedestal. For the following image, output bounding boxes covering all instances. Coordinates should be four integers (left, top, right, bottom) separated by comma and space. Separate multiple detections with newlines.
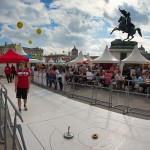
92, 45, 119, 63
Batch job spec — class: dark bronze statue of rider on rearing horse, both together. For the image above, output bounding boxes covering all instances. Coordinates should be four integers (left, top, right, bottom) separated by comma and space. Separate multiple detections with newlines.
110, 9, 142, 41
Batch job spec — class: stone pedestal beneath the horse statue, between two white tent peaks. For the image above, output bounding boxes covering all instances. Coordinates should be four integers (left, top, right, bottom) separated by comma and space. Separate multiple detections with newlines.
109, 39, 138, 60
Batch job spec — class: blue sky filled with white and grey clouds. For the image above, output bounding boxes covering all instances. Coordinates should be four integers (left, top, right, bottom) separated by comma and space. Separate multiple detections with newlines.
0, 0, 150, 55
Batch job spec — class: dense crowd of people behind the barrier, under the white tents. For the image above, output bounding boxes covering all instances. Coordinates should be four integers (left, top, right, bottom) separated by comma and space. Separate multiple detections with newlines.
32, 64, 150, 94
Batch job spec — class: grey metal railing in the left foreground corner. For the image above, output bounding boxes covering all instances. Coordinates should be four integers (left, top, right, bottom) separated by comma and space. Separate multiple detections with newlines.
0, 83, 27, 150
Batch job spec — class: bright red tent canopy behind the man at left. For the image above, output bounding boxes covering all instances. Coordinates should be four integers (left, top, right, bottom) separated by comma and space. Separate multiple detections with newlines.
0, 49, 29, 63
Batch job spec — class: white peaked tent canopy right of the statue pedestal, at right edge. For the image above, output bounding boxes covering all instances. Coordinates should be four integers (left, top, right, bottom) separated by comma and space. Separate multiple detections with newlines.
121, 45, 150, 64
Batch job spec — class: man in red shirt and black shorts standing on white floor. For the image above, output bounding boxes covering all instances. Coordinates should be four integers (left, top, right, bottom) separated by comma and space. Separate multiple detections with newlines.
15, 61, 30, 112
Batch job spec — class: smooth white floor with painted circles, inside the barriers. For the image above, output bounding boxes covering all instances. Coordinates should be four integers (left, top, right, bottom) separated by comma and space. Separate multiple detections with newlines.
3, 80, 150, 150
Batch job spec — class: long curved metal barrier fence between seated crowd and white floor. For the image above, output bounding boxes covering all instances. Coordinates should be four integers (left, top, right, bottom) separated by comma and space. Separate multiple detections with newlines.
32, 72, 150, 116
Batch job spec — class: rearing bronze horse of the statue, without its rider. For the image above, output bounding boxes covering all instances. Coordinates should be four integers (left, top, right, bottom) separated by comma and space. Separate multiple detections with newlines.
110, 16, 142, 41
